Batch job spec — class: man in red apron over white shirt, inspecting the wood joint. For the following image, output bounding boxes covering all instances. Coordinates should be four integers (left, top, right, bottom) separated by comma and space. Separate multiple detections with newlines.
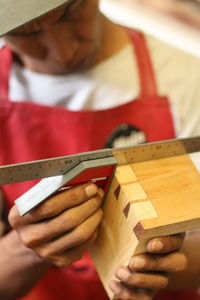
0, 0, 199, 300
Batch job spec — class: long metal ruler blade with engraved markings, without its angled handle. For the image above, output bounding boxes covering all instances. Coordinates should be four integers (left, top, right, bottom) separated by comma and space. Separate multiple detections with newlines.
0, 137, 200, 185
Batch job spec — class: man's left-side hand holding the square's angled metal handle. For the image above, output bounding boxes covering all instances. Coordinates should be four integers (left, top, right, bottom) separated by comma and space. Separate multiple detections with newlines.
9, 183, 103, 266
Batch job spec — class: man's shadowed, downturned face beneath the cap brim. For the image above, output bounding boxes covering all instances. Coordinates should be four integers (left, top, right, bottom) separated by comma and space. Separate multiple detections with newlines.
4, 0, 101, 74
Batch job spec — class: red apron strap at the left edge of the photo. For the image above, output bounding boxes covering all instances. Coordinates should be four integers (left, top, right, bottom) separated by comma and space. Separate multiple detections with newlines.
0, 46, 12, 101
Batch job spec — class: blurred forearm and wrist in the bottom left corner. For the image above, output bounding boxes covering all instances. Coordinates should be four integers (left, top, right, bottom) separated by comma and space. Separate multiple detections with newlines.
0, 231, 49, 300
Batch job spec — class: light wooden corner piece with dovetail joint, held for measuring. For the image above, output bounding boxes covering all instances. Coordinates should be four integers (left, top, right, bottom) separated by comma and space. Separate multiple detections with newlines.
91, 155, 200, 298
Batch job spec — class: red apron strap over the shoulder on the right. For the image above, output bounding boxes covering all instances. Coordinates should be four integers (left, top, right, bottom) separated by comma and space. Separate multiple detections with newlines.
128, 29, 158, 99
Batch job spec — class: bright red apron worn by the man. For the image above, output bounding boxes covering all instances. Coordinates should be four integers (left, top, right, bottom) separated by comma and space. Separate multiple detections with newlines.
0, 32, 200, 300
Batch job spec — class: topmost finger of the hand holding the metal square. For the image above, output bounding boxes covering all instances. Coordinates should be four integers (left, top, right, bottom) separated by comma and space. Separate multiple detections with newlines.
9, 183, 101, 228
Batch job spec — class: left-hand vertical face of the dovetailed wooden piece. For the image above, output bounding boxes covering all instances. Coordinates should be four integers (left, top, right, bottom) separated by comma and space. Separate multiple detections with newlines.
91, 178, 142, 298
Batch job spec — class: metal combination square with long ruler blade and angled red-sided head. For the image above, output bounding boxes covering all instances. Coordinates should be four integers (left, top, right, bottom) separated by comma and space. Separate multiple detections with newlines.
0, 136, 200, 215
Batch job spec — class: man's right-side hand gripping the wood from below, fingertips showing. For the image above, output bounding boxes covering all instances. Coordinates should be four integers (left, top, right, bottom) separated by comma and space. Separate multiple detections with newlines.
110, 234, 187, 300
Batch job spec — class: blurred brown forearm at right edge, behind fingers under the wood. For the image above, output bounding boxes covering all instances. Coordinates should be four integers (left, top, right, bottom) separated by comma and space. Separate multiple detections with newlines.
169, 231, 200, 290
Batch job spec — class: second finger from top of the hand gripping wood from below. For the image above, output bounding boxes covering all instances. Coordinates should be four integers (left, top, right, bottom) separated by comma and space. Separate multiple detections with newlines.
129, 252, 187, 272
